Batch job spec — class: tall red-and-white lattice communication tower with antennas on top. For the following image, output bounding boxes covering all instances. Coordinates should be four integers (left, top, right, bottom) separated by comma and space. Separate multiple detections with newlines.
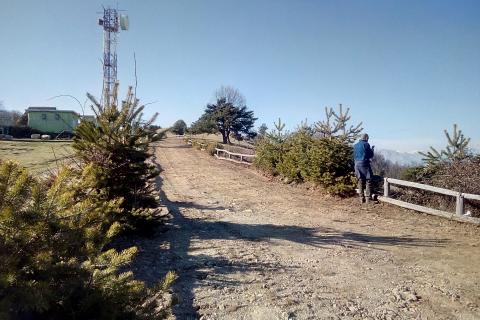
98, 7, 129, 105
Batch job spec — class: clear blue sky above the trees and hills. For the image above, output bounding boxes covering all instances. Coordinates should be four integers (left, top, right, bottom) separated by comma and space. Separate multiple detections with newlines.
0, 0, 480, 151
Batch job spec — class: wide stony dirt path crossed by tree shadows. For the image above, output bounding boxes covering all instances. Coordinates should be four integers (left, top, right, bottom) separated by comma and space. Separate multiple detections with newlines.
129, 138, 480, 319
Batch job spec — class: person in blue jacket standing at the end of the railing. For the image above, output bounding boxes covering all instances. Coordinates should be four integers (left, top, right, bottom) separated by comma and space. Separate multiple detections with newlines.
353, 133, 375, 203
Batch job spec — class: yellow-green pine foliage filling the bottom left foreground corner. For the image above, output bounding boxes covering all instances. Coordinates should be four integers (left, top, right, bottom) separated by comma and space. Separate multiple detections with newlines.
0, 162, 175, 319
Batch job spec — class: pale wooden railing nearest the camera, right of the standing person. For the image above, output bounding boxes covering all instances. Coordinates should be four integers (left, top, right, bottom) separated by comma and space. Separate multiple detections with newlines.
379, 178, 480, 224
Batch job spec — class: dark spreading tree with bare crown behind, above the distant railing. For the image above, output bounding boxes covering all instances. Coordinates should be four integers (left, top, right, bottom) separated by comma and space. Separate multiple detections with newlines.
191, 87, 257, 143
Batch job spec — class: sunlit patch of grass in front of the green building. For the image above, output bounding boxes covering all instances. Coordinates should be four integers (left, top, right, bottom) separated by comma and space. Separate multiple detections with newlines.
0, 140, 73, 173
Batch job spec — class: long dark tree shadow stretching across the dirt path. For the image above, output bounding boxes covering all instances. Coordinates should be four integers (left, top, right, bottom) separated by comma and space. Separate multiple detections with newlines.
129, 156, 448, 319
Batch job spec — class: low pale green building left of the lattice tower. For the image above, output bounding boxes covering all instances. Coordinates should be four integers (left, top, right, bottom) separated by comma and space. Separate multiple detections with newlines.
26, 107, 80, 133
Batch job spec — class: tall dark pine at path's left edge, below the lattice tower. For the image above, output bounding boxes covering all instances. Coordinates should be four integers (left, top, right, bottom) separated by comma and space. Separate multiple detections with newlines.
73, 84, 163, 229
